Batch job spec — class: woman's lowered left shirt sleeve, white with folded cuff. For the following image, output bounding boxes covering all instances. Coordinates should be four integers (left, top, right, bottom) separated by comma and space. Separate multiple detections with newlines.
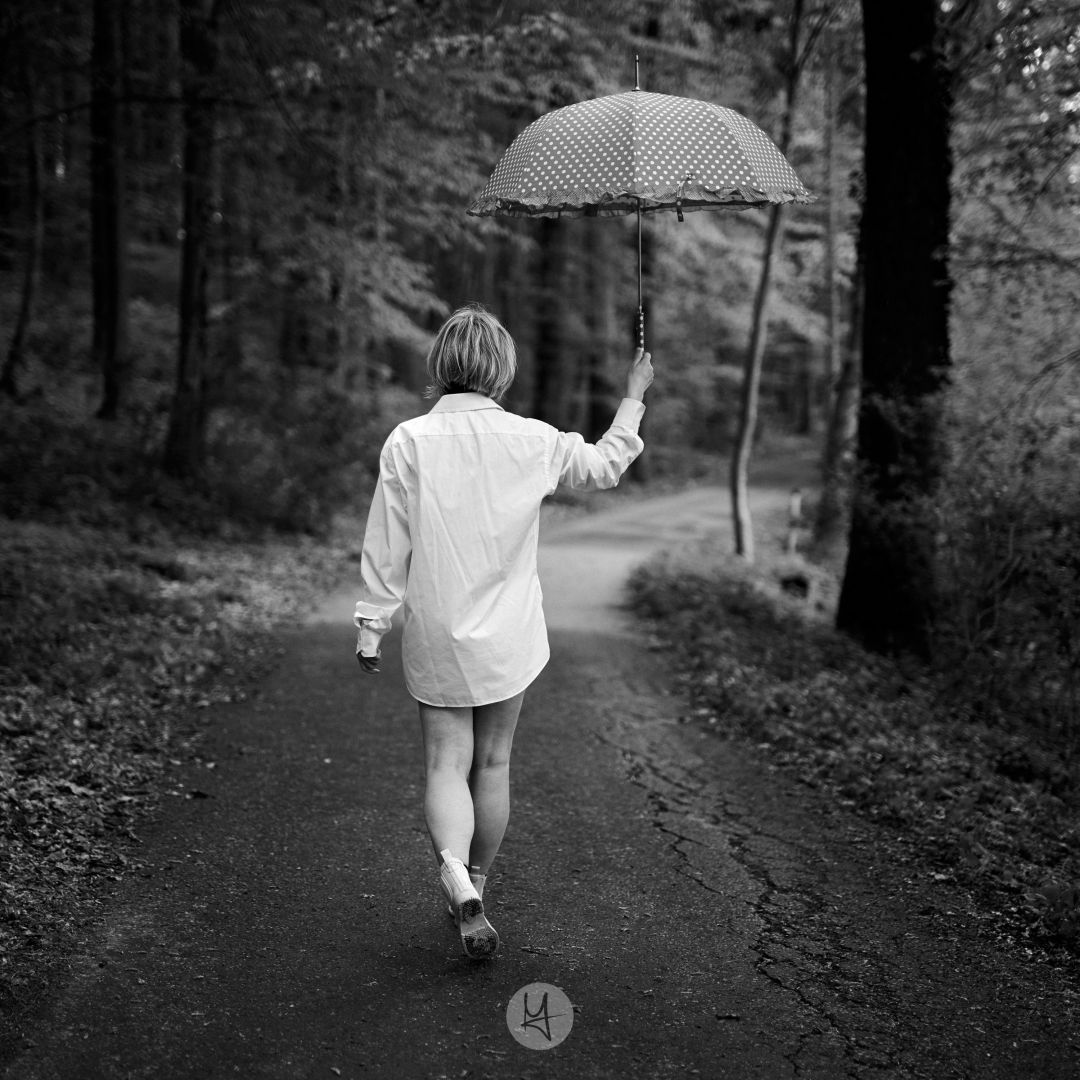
353, 443, 413, 657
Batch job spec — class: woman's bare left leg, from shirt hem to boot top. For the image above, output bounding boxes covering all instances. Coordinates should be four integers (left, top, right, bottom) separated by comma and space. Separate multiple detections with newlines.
420, 702, 474, 863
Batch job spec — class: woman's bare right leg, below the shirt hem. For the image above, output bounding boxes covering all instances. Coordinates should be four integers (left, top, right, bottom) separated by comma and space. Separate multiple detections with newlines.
467, 693, 525, 874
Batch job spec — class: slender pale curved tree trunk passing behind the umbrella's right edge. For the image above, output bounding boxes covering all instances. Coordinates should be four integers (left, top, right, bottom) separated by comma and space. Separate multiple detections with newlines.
730, 0, 802, 563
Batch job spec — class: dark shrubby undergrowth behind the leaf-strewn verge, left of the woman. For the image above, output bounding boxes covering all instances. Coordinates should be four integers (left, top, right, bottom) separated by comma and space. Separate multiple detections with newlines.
0, 384, 401, 536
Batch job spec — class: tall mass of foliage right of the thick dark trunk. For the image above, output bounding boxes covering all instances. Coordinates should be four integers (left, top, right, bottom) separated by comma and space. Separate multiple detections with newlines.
929, 0, 1080, 755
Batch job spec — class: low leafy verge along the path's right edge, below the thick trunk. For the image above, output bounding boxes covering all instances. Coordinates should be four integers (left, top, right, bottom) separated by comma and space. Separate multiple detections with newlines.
631, 549, 1080, 964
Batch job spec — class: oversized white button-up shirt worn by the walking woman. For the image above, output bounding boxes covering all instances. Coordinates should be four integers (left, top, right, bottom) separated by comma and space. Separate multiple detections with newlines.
355, 393, 645, 706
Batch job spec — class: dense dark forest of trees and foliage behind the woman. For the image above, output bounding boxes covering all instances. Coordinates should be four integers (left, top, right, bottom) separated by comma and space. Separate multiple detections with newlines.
0, 0, 1080, 997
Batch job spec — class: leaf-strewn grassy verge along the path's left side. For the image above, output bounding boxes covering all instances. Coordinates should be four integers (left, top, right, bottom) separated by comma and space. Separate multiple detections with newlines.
0, 518, 355, 1022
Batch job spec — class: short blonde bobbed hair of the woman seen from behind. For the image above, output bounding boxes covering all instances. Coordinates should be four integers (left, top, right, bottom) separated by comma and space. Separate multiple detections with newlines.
428, 303, 517, 399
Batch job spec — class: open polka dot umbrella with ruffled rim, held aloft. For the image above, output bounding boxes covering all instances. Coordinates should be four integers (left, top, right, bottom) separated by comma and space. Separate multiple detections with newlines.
469, 83, 814, 348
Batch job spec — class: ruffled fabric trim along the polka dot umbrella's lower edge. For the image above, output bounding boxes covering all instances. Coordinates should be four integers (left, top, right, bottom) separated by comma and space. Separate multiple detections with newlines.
465, 187, 818, 217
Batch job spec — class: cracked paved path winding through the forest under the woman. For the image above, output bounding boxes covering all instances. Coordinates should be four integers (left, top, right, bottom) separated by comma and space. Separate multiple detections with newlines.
0, 489, 1080, 1080
